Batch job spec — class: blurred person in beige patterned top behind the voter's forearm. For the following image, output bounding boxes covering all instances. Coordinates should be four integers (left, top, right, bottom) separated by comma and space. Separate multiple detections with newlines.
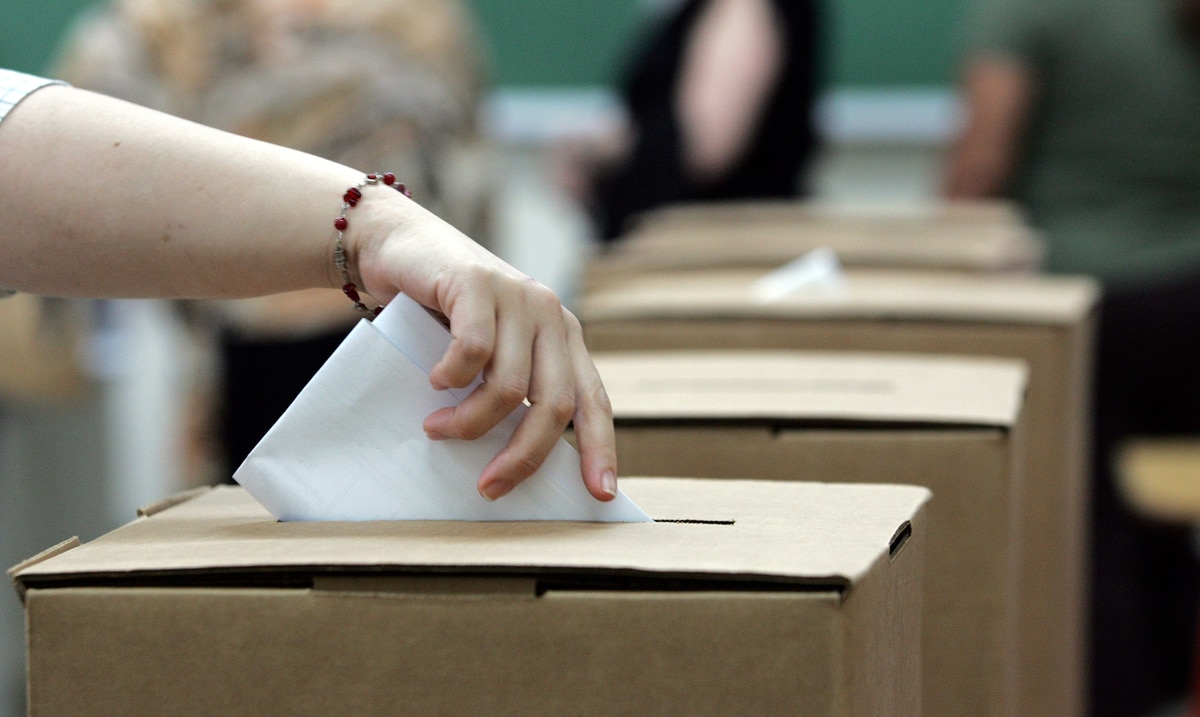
54, 0, 491, 481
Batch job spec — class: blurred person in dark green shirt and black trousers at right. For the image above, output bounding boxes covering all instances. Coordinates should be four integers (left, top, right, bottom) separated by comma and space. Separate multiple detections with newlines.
944, 0, 1200, 717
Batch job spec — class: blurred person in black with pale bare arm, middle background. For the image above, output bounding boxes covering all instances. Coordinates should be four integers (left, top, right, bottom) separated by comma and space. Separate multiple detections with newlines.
562, 0, 820, 241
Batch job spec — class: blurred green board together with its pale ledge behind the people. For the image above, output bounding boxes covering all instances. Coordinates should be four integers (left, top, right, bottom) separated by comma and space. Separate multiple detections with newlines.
0, 0, 965, 147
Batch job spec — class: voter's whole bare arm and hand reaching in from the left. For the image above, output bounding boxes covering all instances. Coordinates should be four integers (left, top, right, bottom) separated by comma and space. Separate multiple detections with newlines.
0, 86, 616, 500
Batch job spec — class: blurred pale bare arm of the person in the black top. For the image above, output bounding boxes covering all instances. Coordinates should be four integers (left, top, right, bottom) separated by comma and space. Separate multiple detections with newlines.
676, 0, 785, 181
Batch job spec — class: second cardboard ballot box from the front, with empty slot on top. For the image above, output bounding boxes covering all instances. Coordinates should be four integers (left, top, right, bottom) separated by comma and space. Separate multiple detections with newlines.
594, 351, 1026, 717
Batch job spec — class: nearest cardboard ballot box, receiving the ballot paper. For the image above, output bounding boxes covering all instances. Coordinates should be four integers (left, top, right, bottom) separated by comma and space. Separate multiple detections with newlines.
12, 478, 929, 717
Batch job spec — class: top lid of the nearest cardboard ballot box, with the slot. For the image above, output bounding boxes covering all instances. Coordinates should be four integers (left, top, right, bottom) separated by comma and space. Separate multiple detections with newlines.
14, 478, 929, 601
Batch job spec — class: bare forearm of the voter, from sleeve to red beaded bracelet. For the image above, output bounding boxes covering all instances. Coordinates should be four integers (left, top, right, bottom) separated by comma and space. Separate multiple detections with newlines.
0, 86, 360, 297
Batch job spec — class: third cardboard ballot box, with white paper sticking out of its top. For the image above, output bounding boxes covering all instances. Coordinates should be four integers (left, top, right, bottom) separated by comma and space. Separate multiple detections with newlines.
578, 271, 1098, 717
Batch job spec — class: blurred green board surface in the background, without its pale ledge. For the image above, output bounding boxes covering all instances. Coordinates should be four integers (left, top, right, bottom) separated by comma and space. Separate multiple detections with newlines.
0, 0, 966, 88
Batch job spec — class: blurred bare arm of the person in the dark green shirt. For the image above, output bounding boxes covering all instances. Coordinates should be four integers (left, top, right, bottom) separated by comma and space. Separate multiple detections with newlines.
943, 58, 1033, 199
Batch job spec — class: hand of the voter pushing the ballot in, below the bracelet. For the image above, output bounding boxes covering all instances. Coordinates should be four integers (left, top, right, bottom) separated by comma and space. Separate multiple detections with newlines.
347, 189, 617, 500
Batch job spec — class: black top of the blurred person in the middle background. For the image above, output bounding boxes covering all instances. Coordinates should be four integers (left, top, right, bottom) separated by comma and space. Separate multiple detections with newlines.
594, 0, 818, 240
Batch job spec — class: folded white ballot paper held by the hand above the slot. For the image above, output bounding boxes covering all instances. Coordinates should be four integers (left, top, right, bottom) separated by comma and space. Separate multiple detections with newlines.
234, 295, 650, 523
